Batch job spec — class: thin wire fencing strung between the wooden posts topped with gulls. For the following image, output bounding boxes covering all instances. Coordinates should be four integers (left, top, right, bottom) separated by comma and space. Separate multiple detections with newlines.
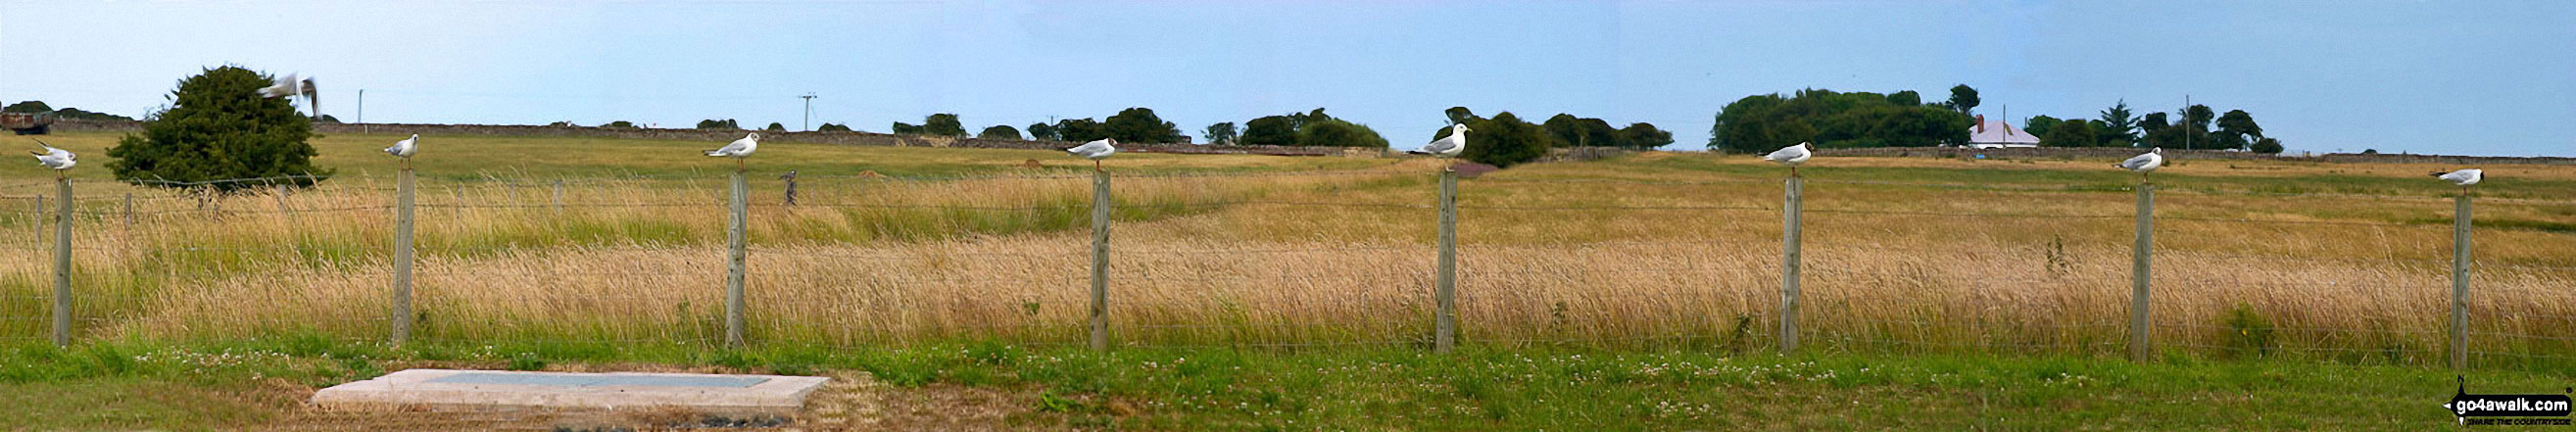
0, 169, 2576, 365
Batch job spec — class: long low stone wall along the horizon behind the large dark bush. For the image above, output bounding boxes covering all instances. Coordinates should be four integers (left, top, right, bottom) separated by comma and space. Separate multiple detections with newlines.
54, 120, 1381, 157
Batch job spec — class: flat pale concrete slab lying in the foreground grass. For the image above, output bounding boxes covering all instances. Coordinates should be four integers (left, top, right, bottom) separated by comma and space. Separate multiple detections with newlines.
312, 370, 830, 416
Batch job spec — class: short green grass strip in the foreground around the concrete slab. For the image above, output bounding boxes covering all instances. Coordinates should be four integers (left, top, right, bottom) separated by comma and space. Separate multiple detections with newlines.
0, 334, 2576, 429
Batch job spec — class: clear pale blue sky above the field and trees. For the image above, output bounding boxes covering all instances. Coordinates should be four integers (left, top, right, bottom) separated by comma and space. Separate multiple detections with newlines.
0, 0, 2576, 157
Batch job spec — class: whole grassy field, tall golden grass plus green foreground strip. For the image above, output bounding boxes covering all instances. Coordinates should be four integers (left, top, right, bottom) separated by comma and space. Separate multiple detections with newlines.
0, 134, 2576, 429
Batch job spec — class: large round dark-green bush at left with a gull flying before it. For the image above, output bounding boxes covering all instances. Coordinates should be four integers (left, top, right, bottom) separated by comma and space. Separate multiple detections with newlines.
108, 67, 332, 193
